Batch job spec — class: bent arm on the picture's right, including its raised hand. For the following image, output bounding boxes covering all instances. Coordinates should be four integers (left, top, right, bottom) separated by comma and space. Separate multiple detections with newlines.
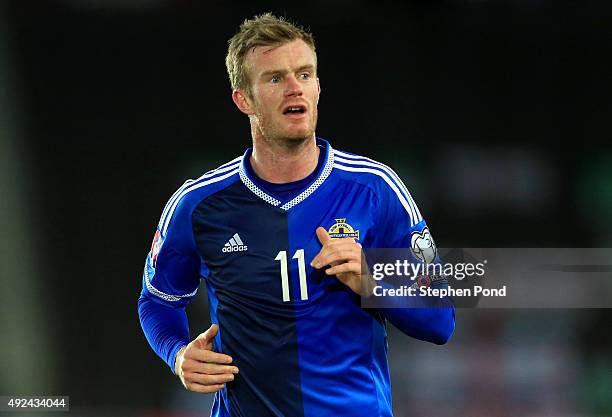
311, 167, 455, 344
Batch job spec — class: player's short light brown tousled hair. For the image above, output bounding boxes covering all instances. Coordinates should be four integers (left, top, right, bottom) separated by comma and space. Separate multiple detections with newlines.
225, 13, 317, 96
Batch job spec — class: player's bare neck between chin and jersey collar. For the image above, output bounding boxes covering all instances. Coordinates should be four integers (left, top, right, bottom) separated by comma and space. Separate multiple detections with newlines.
251, 135, 319, 184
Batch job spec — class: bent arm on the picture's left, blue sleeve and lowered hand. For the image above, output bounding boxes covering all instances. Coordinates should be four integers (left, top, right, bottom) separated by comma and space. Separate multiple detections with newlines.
138, 193, 238, 393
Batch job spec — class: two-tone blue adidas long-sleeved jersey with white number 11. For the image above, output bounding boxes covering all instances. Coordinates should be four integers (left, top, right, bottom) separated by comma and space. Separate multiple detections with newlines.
139, 139, 454, 417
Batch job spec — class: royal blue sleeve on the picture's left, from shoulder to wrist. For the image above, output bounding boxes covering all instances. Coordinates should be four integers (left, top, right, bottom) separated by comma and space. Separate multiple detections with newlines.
138, 190, 202, 372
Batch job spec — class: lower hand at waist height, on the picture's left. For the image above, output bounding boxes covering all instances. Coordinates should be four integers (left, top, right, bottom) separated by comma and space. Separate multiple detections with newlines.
174, 324, 238, 394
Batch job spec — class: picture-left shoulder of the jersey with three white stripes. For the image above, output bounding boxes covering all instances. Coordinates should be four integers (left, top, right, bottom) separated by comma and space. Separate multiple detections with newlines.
158, 156, 242, 235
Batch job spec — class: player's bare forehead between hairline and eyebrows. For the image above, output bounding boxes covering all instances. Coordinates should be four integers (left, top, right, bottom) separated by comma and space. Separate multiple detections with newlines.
246, 39, 316, 77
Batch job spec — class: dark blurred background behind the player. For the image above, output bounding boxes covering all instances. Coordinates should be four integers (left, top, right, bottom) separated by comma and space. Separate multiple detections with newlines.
0, 0, 612, 417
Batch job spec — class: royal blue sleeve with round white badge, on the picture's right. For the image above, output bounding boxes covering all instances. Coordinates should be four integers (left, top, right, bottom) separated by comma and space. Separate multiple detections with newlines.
368, 169, 455, 344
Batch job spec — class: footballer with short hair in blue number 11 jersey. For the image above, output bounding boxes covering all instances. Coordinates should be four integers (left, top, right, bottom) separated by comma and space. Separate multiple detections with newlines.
139, 14, 454, 417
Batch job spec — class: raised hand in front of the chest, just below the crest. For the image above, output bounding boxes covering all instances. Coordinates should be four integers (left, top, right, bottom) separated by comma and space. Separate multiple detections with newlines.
310, 227, 374, 297
